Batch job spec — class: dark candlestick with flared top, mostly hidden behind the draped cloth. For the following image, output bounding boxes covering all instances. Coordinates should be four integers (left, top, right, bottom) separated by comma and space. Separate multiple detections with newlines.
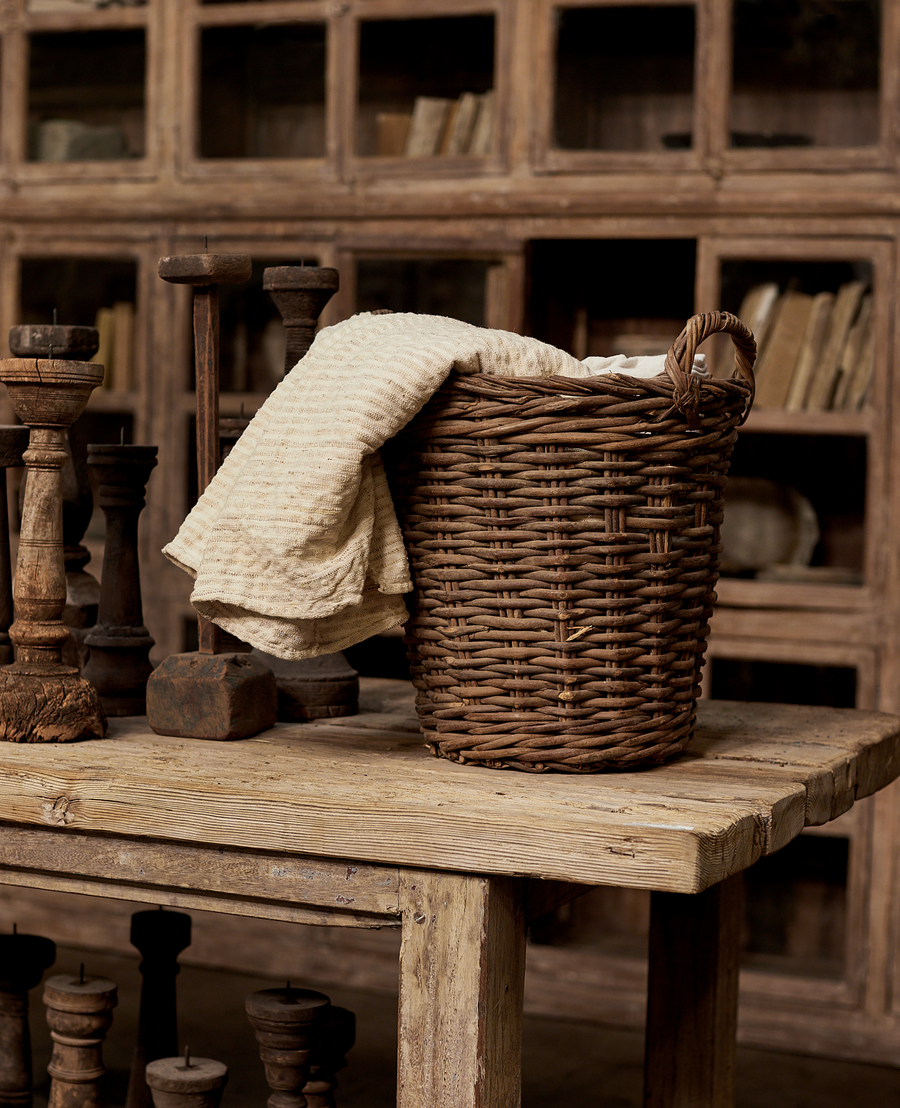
254, 266, 359, 721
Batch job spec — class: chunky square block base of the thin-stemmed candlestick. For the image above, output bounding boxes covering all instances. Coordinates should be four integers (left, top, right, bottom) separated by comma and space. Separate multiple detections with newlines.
147, 653, 278, 739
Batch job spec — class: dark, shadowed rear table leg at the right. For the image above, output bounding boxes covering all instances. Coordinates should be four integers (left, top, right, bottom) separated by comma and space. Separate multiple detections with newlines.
644, 873, 744, 1108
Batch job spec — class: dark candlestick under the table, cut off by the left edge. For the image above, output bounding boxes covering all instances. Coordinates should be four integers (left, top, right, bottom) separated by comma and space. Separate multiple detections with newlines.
0, 933, 57, 1108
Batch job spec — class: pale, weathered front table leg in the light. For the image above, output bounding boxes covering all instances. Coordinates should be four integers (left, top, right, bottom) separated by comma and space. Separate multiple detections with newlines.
397, 872, 525, 1108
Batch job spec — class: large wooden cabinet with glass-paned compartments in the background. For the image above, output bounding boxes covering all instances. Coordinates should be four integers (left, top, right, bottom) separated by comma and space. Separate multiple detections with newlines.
0, 0, 900, 1063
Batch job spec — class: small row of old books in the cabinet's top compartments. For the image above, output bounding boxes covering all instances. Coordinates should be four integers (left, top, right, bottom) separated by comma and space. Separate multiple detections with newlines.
376, 89, 494, 157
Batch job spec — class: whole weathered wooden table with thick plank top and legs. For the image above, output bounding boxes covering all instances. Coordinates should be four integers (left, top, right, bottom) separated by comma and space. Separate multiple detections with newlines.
0, 681, 900, 1108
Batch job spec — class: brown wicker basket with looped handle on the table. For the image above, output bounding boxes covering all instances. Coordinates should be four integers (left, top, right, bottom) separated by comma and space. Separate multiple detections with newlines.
386, 312, 756, 773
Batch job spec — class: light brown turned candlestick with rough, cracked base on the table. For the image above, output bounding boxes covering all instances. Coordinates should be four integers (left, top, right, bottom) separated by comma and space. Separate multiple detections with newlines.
0, 358, 105, 742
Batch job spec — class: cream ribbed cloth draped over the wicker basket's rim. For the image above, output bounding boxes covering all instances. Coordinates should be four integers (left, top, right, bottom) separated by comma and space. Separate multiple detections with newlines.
163, 314, 682, 658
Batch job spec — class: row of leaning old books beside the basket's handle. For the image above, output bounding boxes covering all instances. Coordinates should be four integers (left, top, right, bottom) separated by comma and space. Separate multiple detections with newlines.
738, 280, 875, 411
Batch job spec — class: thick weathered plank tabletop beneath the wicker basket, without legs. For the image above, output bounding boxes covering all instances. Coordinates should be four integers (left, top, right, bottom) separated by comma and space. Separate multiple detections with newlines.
0, 681, 900, 892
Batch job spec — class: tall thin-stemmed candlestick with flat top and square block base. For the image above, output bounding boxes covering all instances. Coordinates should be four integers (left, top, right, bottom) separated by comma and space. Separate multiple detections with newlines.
147, 254, 278, 739
